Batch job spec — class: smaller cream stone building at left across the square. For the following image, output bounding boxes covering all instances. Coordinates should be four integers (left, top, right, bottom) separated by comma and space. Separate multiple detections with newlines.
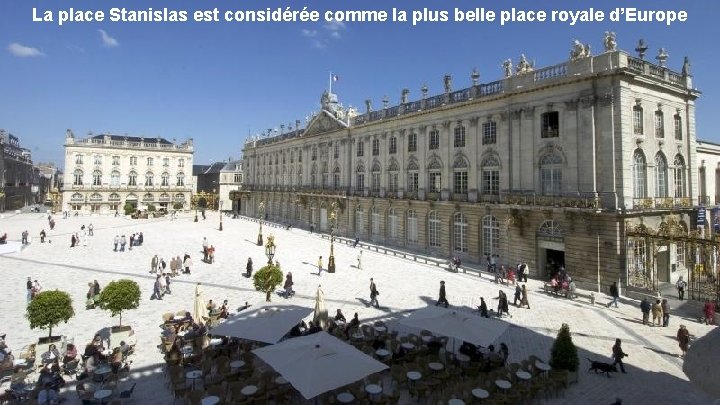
62, 130, 193, 213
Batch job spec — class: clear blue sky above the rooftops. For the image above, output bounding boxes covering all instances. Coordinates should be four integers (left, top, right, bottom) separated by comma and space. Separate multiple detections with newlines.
0, 0, 720, 166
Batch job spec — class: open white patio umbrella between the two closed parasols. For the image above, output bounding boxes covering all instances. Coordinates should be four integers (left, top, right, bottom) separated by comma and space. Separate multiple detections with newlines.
210, 305, 313, 344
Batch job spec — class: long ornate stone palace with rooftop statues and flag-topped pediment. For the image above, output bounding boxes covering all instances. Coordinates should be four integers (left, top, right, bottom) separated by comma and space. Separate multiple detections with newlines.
240, 33, 705, 291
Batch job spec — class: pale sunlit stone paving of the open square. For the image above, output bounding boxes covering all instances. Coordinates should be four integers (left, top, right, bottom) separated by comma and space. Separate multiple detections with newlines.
0, 212, 715, 405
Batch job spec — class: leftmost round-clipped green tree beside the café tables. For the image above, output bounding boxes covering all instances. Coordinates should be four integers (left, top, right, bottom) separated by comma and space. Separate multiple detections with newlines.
25, 290, 75, 336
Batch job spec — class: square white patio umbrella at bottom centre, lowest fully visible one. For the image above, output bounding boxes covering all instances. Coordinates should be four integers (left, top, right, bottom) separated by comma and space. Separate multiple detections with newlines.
253, 332, 387, 399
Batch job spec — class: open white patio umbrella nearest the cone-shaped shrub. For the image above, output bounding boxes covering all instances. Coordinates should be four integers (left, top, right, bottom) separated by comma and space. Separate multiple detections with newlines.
400, 306, 508, 346
